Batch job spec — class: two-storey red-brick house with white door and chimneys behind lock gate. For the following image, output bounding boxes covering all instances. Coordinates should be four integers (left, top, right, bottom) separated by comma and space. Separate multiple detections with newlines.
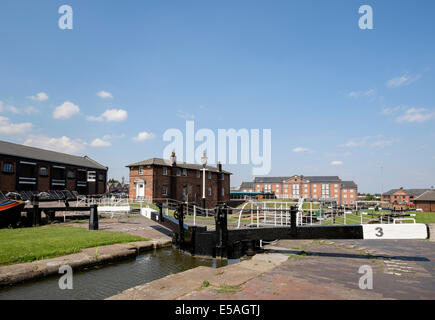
127, 158, 231, 208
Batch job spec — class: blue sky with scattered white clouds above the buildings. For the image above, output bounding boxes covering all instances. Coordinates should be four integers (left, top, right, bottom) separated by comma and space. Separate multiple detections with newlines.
0, 0, 435, 192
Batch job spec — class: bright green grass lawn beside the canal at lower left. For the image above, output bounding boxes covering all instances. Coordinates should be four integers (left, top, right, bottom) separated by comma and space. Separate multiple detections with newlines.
0, 226, 149, 266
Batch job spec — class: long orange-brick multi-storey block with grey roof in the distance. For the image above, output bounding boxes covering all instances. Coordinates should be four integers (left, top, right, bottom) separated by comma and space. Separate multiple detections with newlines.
240, 175, 358, 204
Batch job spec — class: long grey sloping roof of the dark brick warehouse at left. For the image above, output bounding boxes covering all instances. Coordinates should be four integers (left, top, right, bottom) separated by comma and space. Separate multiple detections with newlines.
0, 140, 107, 170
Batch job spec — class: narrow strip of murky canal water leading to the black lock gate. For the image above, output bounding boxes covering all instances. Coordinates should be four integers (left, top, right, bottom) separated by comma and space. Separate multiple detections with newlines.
0, 248, 238, 300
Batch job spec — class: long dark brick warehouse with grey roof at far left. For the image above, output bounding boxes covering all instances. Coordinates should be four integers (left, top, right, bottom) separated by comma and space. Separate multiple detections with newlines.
0, 141, 108, 195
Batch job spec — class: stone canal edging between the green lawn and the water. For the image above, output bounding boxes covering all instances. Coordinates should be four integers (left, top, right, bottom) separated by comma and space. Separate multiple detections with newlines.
0, 239, 172, 287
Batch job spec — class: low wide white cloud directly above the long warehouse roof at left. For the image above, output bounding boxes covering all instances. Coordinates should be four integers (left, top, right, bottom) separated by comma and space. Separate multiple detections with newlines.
24, 135, 87, 154
